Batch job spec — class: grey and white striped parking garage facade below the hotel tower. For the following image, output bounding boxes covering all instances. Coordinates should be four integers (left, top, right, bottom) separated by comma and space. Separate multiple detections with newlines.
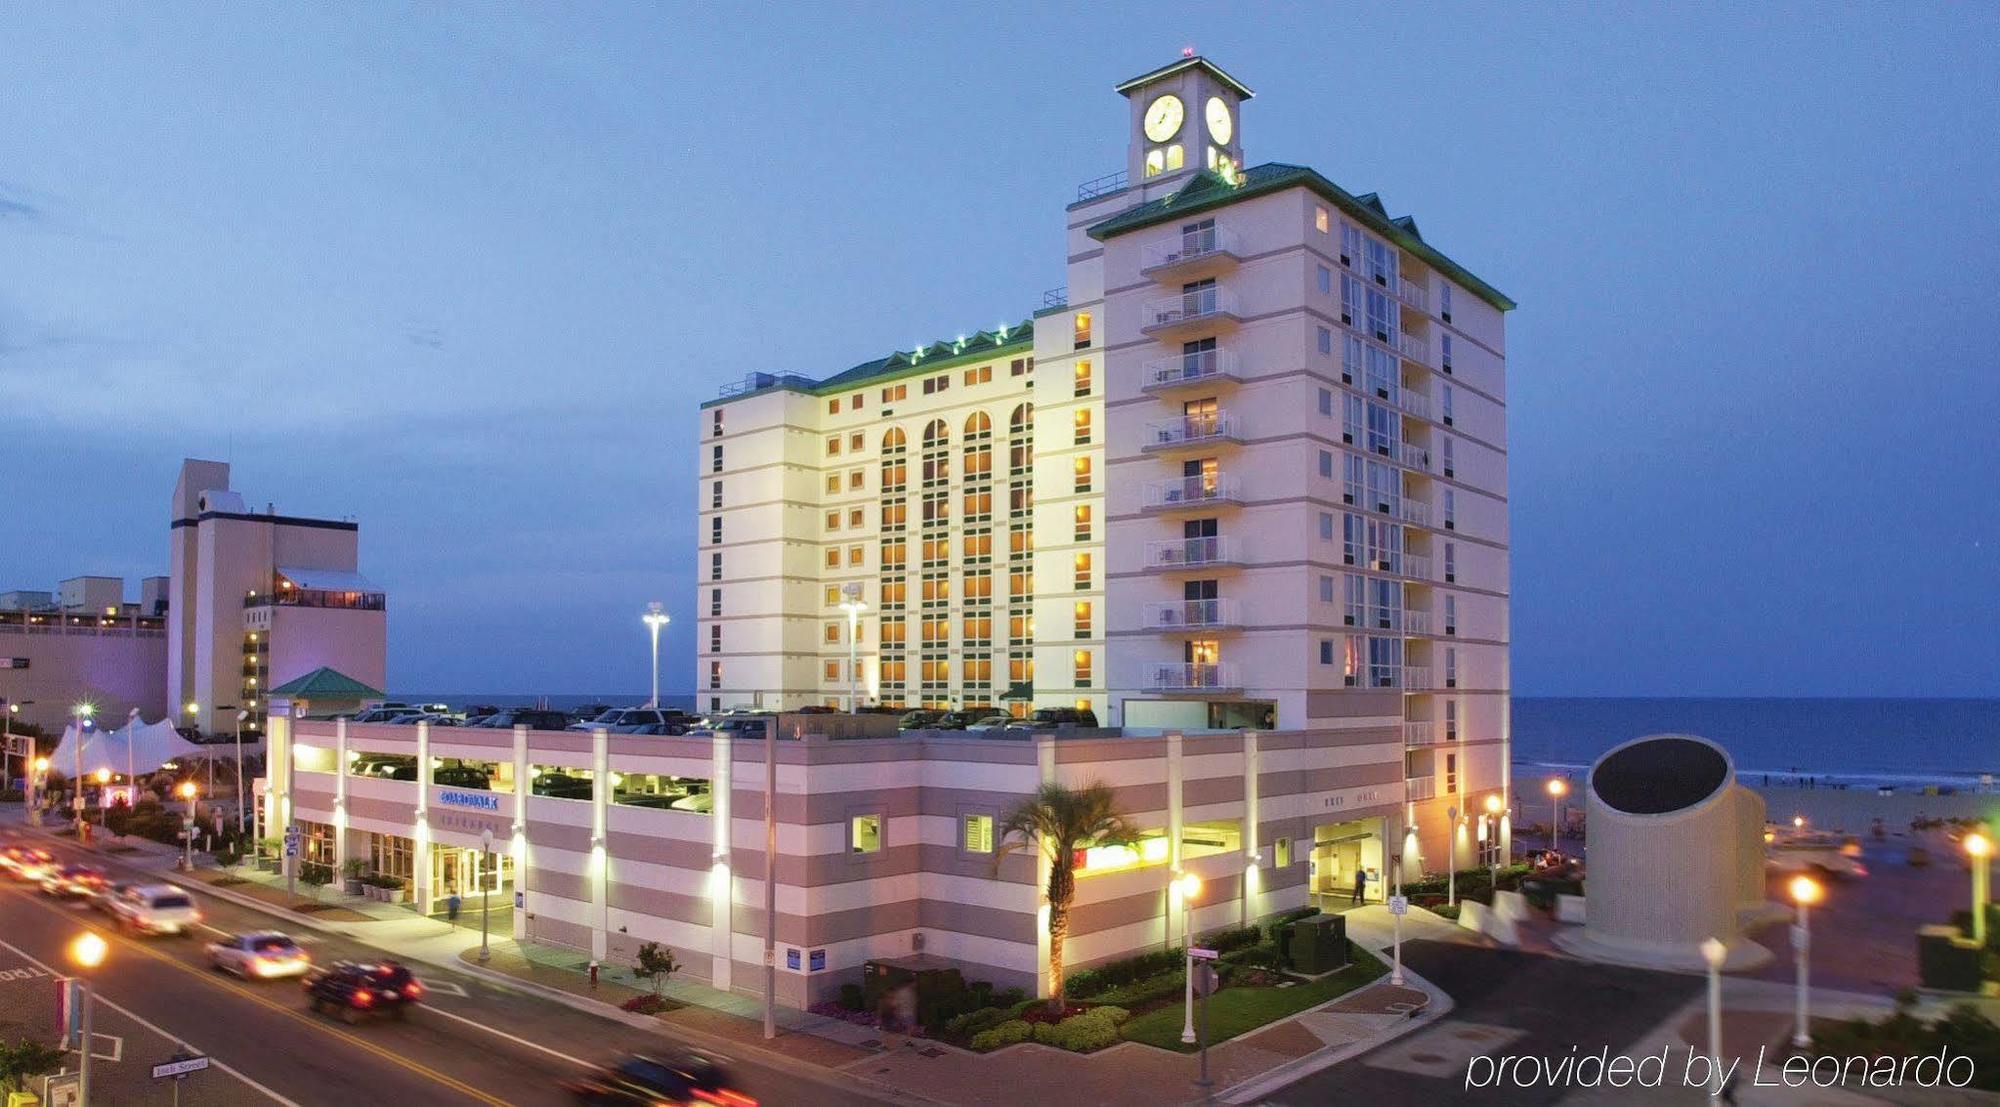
266, 711, 1414, 1007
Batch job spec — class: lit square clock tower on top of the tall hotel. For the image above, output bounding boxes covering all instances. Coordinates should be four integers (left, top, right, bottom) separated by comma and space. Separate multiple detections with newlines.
1118, 54, 1254, 200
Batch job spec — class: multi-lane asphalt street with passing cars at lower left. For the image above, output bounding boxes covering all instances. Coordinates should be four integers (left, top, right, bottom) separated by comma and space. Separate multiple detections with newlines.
0, 827, 884, 1107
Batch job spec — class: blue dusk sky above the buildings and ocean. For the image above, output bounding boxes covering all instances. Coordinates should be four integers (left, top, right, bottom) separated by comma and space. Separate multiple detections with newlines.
0, 4, 2000, 695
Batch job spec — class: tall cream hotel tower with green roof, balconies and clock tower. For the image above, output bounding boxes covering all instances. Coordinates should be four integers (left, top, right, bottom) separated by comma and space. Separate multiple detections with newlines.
696, 58, 1514, 851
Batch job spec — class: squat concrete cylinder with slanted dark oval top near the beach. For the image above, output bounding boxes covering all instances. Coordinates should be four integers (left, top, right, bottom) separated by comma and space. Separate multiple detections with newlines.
1556, 733, 1772, 971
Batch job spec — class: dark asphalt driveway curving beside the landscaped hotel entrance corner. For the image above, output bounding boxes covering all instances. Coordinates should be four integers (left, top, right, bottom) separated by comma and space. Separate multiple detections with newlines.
1266, 941, 1704, 1107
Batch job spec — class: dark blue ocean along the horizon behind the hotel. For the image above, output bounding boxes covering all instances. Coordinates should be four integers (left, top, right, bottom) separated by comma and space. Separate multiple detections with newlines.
396, 691, 2000, 787
